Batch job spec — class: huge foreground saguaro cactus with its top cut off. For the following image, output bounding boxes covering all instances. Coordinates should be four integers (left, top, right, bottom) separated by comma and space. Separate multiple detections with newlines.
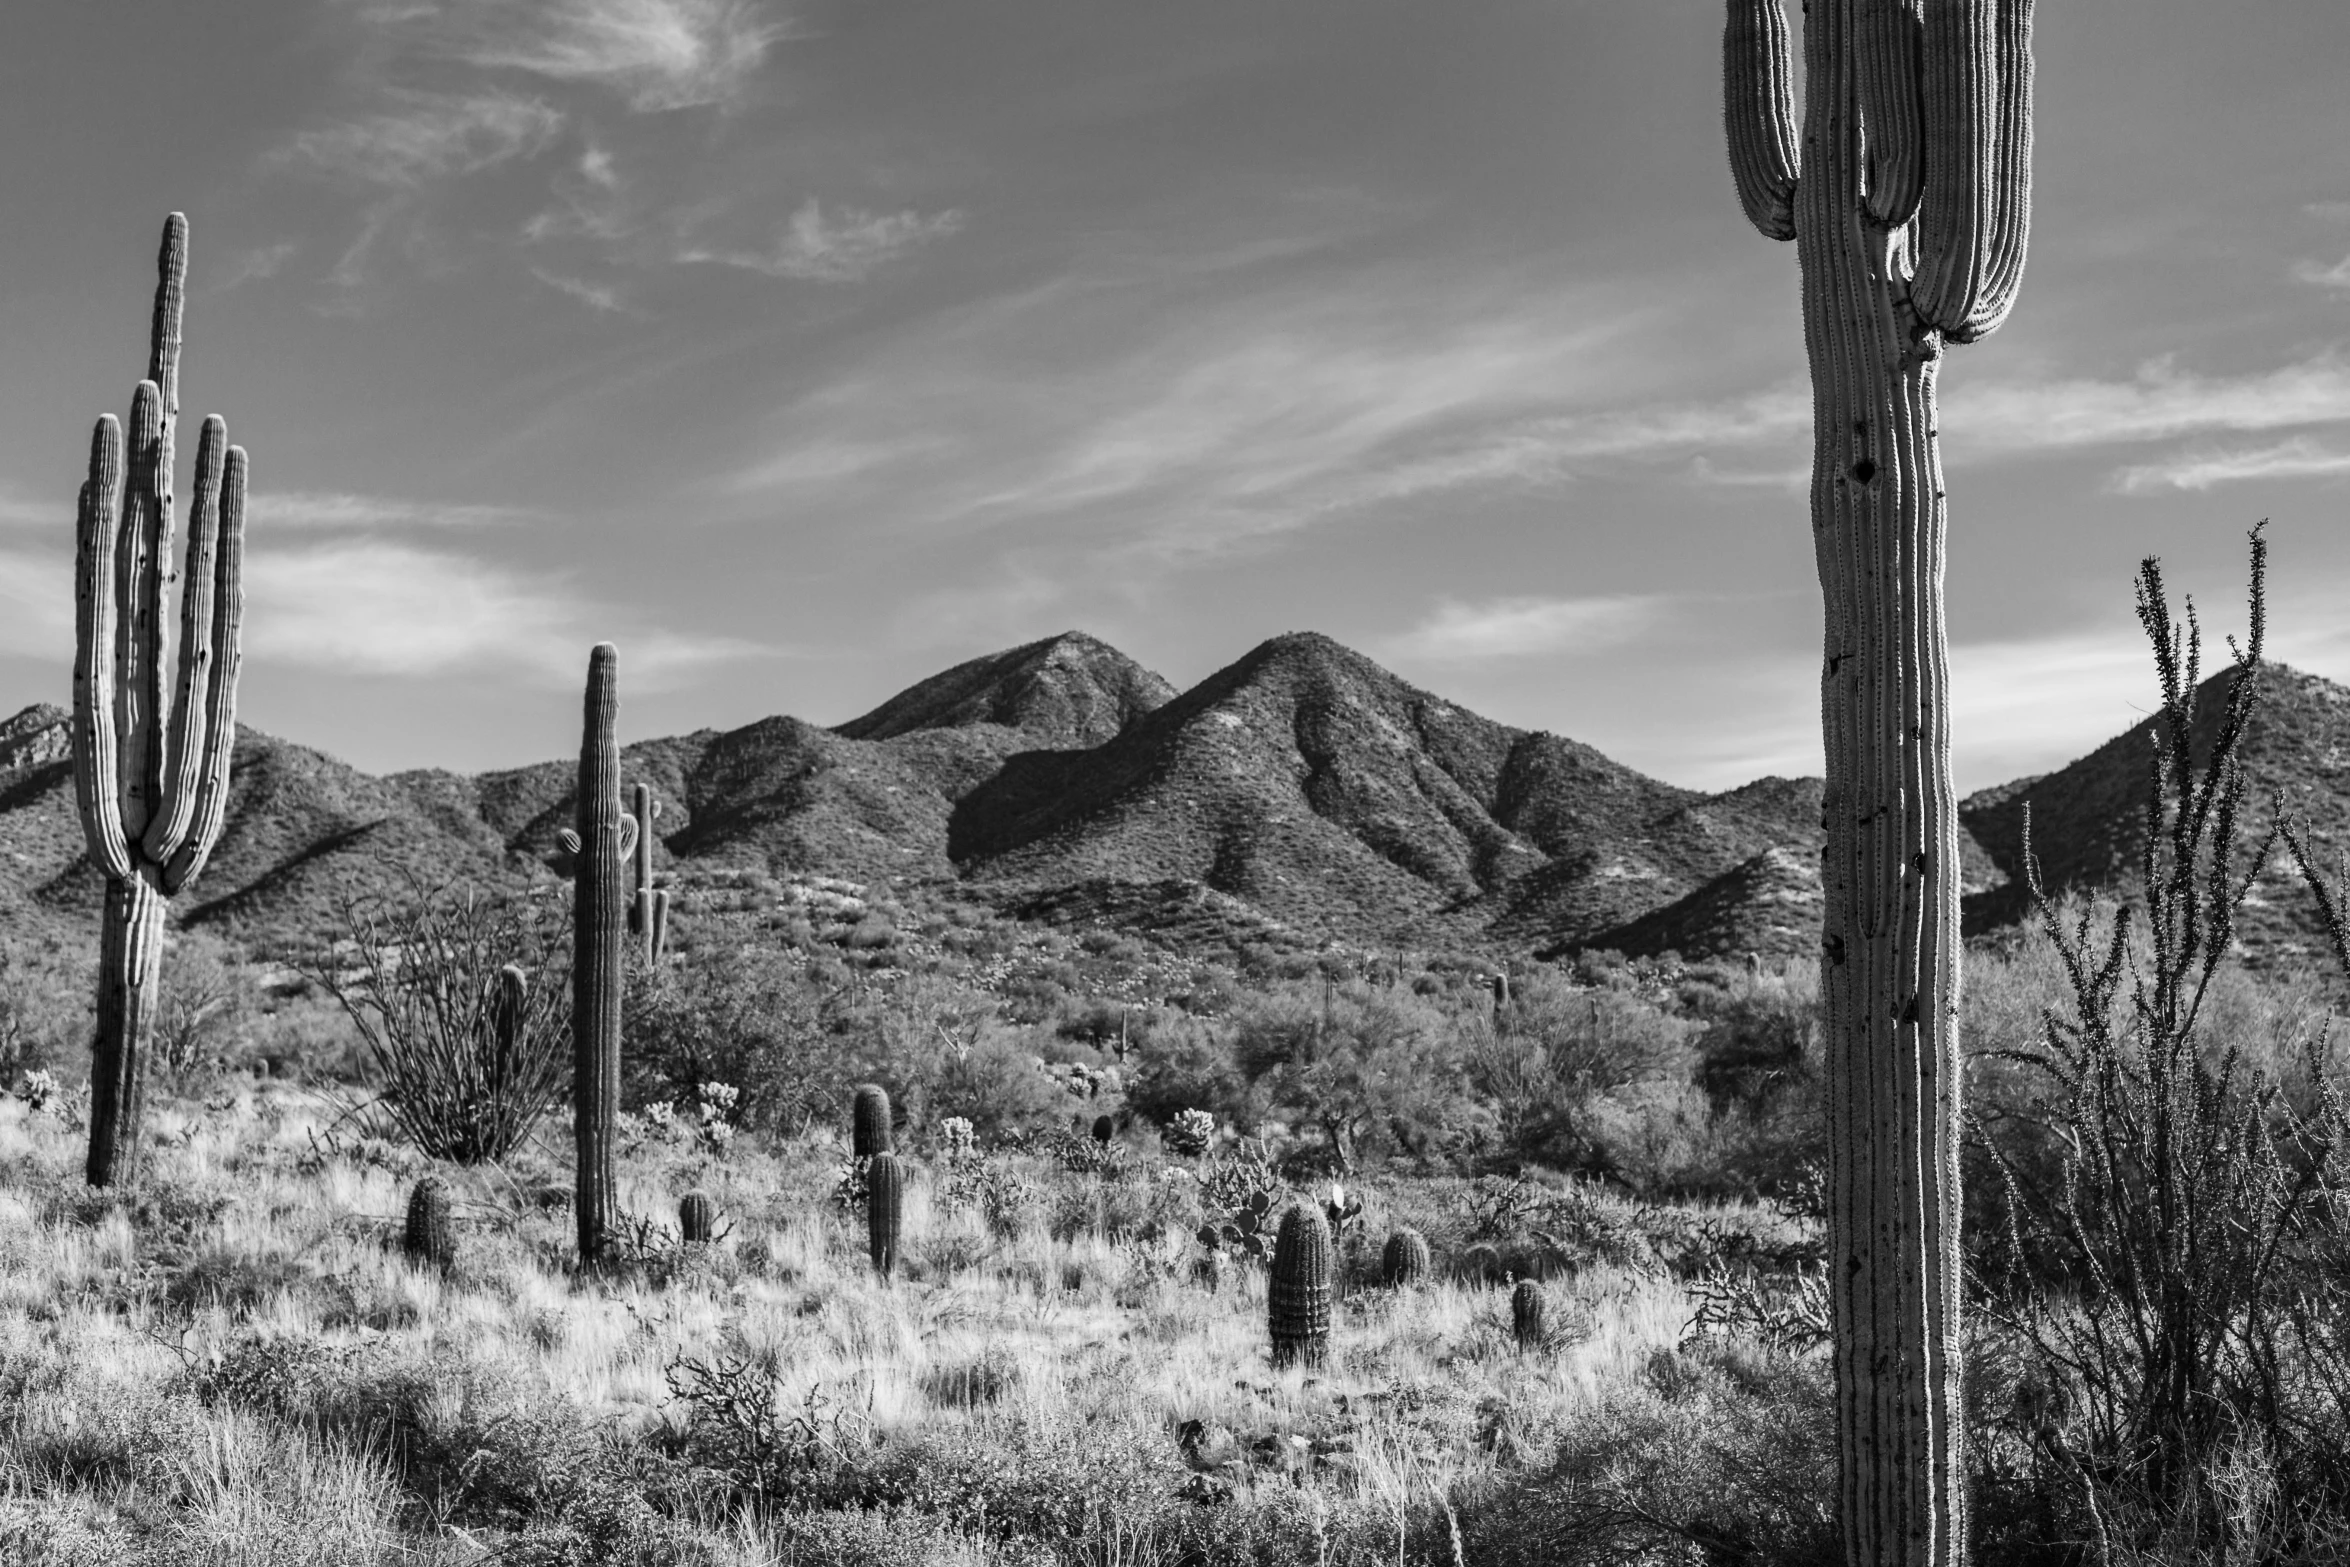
1723, 0, 2033, 1565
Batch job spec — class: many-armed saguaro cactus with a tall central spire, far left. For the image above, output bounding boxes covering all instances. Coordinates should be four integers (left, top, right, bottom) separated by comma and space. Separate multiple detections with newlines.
73, 211, 247, 1186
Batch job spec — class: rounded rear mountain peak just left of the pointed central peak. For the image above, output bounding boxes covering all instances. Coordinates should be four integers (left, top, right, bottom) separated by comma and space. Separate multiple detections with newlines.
832, 632, 1175, 749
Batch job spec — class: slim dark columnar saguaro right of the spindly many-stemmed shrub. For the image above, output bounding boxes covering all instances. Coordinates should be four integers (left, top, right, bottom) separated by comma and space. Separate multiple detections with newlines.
564, 641, 637, 1266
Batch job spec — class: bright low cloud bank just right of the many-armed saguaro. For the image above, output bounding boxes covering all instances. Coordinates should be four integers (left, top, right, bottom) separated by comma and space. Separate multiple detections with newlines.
249, 540, 773, 686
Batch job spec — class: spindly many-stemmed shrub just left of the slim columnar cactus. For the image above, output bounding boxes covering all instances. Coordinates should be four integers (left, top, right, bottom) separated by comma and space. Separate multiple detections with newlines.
298, 872, 571, 1163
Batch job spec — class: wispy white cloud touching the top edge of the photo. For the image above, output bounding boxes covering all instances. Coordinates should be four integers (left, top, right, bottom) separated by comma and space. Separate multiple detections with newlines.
427, 0, 787, 110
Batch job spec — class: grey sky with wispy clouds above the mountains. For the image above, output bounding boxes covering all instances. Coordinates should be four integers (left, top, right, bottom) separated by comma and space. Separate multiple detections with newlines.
0, 0, 2350, 789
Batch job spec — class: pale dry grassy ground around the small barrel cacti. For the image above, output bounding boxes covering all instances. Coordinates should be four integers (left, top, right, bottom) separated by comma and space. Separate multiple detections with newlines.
0, 1090, 1777, 1565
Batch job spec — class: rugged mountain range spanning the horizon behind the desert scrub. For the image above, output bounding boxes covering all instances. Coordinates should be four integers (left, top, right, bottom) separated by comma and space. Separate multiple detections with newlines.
0, 632, 2350, 959
